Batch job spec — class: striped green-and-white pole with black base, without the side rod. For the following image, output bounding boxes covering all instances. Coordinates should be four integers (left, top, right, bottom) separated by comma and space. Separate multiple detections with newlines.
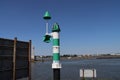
52, 23, 61, 80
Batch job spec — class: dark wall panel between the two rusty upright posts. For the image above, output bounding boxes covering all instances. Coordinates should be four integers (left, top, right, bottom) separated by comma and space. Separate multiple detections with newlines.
16, 41, 29, 79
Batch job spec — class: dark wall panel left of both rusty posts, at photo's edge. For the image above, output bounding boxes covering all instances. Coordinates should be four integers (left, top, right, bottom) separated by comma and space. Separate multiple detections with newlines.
0, 38, 14, 80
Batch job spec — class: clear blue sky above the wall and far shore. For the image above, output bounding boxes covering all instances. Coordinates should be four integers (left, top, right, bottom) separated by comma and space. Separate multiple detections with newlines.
0, 0, 120, 55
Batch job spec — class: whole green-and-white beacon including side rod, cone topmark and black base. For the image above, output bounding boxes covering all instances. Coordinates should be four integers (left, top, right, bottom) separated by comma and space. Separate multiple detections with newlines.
43, 11, 61, 80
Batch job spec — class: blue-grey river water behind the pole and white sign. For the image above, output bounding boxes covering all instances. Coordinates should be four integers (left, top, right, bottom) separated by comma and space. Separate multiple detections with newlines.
28, 59, 120, 80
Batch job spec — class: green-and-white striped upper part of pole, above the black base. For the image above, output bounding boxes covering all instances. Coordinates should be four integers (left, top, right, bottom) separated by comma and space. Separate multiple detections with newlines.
52, 23, 61, 68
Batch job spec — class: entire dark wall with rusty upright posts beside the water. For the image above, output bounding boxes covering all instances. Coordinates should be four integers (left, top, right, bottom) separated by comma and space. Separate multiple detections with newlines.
0, 38, 31, 80
